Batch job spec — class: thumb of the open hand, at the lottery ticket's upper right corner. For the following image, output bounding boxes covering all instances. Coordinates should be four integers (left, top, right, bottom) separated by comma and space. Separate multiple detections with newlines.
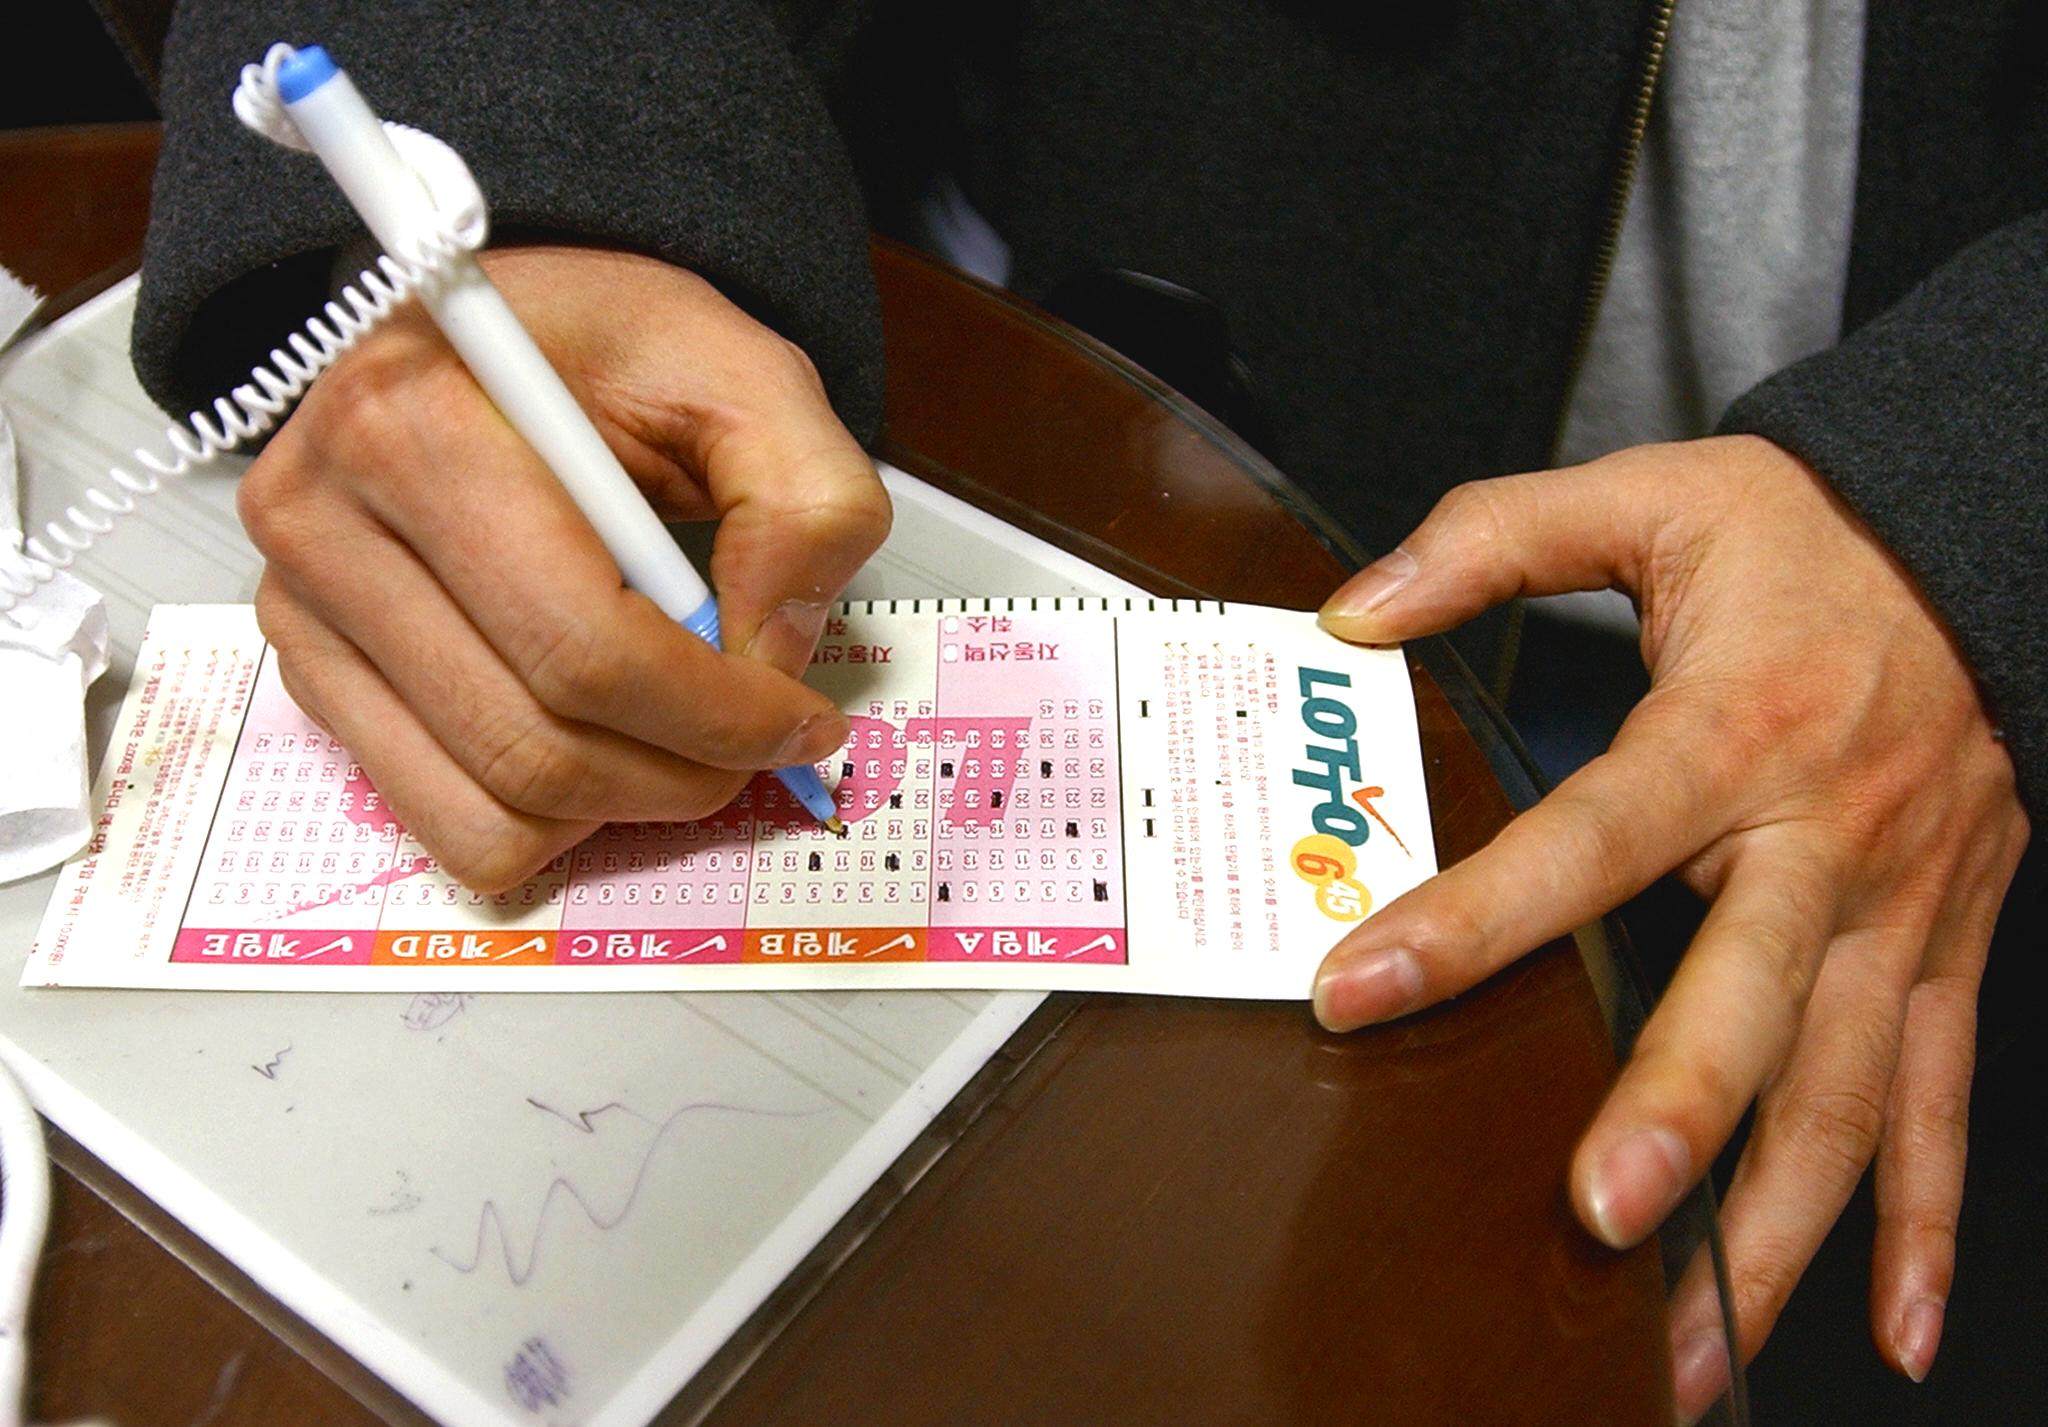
1317, 463, 1647, 645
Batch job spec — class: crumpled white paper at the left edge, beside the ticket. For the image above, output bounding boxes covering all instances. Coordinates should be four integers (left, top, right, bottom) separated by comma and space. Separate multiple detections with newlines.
0, 268, 109, 882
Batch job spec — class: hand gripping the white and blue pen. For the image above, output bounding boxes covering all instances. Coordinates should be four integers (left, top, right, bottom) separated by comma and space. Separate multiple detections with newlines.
240, 248, 889, 891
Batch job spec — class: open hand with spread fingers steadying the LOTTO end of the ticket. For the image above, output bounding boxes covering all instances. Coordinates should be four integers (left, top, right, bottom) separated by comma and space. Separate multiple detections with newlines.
1315, 436, 2028, 1415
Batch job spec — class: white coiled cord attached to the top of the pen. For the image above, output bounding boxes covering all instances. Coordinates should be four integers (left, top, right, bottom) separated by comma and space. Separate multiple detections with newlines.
0, 45, 489, 614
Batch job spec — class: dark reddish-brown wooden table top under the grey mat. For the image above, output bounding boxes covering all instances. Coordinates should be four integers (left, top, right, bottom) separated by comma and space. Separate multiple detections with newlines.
0, 125, 1736, 1427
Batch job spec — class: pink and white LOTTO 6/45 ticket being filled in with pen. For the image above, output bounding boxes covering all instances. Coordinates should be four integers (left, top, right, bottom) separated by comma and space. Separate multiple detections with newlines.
23, 598, 1436, 999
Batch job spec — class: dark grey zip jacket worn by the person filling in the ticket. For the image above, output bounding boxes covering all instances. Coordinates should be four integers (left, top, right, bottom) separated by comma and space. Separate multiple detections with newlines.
135, 0, 2048, 815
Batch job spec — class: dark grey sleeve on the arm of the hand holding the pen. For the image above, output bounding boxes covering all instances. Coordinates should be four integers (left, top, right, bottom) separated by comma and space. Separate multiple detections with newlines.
133, 0, 883, 440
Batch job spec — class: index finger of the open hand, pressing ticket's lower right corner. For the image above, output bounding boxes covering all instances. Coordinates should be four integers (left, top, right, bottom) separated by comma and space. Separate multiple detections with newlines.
1315, 692, 1737, 1030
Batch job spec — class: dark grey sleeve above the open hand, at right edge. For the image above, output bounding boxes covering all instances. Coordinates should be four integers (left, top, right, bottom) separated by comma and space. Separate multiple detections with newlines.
1722, 213, 2048, 823
